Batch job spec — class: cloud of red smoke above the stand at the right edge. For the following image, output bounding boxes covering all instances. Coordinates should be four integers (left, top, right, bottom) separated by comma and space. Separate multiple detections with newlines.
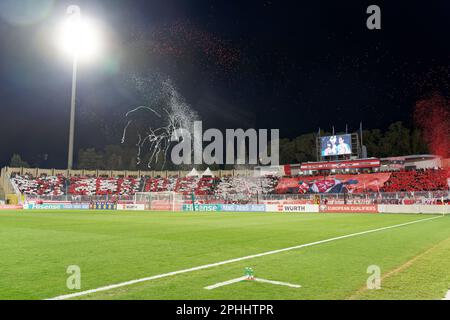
414, 93, 450, 158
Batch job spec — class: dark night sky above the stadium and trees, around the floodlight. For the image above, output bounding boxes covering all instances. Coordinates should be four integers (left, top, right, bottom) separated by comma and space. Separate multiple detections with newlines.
0, 0, 450, 168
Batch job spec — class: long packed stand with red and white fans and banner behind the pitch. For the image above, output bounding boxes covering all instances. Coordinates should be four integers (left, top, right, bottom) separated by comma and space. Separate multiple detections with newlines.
11, 169, 450, 199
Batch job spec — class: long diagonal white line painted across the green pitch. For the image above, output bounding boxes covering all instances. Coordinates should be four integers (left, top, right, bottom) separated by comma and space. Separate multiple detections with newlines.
47, 216, 442, 300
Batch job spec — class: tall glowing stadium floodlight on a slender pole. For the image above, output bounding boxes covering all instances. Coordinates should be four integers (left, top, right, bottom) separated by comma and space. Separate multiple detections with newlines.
59, 5, 100, 169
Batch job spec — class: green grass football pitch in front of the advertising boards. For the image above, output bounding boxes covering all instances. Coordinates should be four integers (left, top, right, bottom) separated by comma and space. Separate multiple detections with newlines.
0, 211, 450, 299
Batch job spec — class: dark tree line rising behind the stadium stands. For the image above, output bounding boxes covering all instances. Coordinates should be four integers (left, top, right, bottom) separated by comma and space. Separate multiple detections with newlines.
9, 121, 429, 170
